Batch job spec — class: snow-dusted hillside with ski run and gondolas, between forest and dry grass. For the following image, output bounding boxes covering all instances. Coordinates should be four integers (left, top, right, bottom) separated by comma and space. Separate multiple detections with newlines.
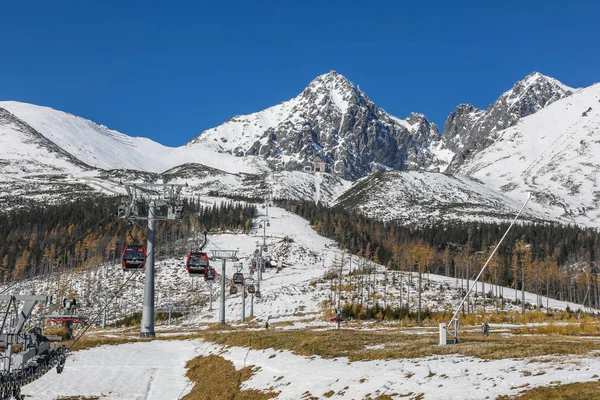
7, 203, 582, 327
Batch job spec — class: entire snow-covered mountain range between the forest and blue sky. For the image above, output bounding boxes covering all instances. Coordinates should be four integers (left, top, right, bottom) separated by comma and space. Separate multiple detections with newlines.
0, 71, 600, 230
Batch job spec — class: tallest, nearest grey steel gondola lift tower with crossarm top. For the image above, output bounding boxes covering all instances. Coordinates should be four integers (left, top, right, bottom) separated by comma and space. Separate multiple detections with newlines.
118, 183, 186, 338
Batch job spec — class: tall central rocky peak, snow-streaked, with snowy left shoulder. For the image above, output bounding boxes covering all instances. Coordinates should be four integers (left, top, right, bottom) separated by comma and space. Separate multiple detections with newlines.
189, 71, 440, 179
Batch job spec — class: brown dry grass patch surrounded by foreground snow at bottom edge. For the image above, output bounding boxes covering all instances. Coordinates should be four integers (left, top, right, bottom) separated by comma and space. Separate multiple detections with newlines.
183, 355, 277, 400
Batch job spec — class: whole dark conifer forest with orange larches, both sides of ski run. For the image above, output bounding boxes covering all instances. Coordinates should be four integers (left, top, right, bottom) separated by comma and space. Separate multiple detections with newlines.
0, 198, 600, 307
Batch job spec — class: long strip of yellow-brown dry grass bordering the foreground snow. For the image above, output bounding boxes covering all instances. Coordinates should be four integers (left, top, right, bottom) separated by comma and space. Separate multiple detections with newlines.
202, 329, 600, 361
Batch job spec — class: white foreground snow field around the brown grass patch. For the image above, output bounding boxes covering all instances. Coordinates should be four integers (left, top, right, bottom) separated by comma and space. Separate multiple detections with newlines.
23, 339, 600, 400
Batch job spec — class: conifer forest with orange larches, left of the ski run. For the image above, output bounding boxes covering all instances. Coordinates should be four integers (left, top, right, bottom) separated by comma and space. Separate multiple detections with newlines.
0, 197, 256, 283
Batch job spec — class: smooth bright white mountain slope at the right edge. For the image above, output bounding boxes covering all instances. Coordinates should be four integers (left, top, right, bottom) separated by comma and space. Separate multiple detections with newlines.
458, 84, 600, 227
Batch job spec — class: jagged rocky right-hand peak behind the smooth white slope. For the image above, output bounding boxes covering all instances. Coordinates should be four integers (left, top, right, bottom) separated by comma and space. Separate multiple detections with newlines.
432, 72, 574, 172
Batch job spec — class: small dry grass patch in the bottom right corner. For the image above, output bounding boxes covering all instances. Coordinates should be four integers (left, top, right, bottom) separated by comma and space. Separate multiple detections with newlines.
496, 382, 600, 400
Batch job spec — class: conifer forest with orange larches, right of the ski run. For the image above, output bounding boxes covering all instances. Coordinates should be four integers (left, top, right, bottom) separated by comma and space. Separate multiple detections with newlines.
277, 200, 600, 307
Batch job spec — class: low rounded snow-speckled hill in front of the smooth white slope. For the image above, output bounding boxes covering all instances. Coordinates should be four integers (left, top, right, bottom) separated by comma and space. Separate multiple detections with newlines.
337, 171, 542, 224
